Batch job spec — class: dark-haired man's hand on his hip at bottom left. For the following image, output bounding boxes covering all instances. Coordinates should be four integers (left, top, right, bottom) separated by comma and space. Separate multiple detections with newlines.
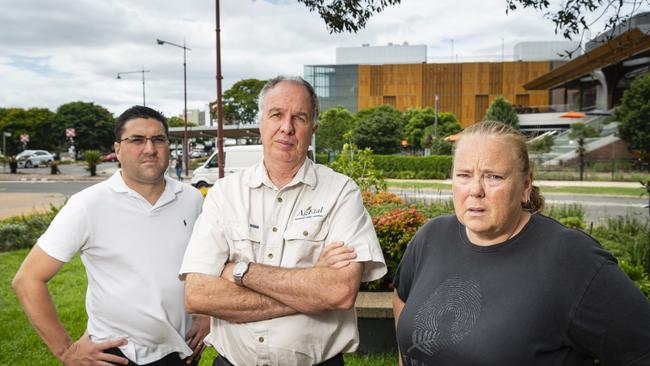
61, 333, 129, 366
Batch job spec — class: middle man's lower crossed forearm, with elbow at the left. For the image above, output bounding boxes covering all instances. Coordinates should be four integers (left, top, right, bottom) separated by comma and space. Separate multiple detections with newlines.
185, 273, 297, 323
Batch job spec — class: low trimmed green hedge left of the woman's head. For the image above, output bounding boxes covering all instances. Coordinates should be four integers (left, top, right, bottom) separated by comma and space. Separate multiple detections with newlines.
373, 155, 452, 179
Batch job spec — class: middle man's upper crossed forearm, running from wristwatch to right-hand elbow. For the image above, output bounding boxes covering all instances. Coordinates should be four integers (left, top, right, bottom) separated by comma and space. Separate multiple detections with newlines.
243, 262, 363, 314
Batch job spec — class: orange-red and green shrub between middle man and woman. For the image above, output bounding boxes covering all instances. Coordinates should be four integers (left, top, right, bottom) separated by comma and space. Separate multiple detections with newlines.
363, 207, 426, 291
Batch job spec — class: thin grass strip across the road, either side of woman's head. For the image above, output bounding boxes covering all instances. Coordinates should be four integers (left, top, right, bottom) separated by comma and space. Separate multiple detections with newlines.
387, 181, 645, 197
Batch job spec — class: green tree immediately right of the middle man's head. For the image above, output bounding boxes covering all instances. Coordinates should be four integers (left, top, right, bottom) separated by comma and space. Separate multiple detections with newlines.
316, 107, 354, 152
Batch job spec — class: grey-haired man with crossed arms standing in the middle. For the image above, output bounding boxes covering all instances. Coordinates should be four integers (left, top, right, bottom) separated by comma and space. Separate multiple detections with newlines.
180, 77, 386, 366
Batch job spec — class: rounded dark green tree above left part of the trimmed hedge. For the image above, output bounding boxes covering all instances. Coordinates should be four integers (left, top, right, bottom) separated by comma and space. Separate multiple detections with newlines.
352, 105, 403, 154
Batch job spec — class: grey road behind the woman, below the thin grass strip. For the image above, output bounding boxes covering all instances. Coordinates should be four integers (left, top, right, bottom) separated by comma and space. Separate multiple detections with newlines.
391, 189, 648, 223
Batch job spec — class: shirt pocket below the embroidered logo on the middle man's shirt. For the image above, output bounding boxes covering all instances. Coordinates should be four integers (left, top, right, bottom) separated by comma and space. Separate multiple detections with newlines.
281, 220, 329, 268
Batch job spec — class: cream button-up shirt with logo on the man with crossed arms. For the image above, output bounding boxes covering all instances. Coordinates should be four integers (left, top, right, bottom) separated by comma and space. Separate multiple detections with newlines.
180, 159, 386, 365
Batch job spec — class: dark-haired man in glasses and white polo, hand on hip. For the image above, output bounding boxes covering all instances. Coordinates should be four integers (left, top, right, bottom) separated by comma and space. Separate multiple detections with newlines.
13, 106, 209, 365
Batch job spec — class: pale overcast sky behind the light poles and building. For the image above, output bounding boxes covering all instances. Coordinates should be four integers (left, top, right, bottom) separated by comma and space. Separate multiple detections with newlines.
0, 0, 620, 116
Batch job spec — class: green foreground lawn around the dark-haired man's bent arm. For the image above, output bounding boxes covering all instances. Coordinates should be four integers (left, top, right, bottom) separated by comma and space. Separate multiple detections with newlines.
0, 249, 397, 366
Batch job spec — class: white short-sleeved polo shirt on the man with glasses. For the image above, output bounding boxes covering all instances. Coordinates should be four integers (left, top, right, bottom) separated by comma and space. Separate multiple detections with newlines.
37, 170, 203, 364
